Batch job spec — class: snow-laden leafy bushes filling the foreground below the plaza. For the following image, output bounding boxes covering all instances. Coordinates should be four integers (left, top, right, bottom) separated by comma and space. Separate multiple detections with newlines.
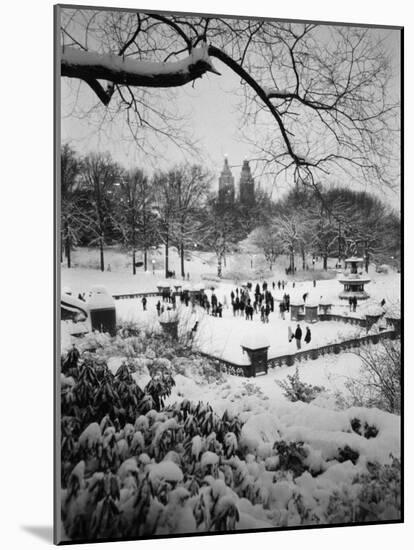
61, 334, 400, 541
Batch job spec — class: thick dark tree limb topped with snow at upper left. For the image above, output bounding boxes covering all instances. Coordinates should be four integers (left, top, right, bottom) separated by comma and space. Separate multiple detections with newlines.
61, 44, 220, 98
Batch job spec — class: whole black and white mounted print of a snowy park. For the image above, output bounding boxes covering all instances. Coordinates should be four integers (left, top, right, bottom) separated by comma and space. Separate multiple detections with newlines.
54, 2, 404, 544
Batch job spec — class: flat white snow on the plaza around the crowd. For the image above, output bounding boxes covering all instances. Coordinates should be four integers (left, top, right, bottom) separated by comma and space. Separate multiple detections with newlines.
62, 249, 400, 364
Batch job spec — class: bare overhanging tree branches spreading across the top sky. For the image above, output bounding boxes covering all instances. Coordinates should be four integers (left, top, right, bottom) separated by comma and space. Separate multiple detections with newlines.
61, 8, 399, 192
